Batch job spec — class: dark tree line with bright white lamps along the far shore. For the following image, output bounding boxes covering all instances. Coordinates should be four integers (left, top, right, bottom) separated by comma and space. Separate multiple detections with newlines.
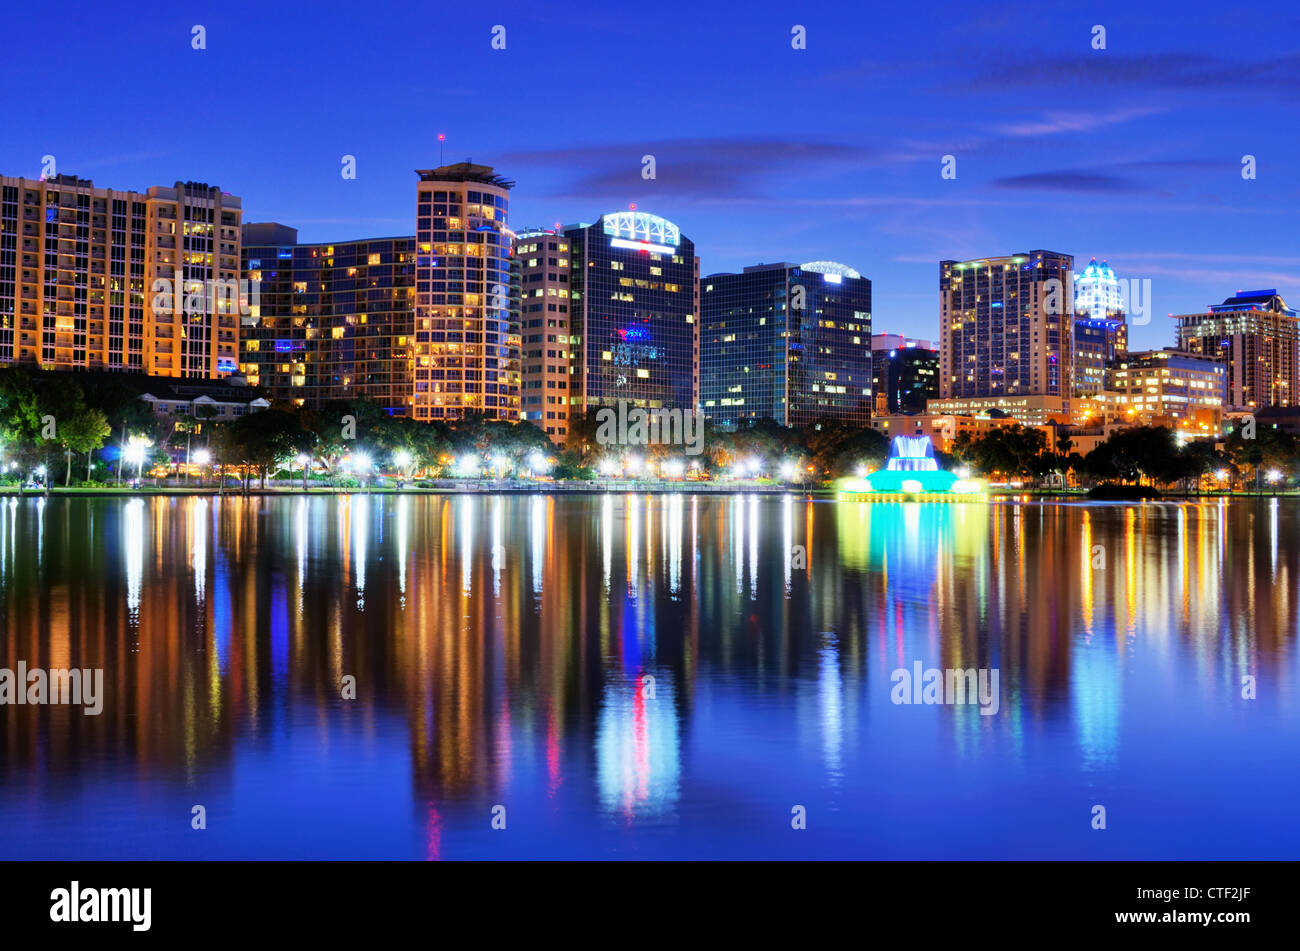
0, 368, 1300, 500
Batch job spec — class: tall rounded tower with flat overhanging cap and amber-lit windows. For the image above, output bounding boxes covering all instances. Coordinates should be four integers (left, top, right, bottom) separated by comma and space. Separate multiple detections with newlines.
412, 162, 520, 421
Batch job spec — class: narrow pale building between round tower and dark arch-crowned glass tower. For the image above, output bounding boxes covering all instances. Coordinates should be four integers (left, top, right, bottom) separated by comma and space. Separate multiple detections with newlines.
515, 229, 580, 444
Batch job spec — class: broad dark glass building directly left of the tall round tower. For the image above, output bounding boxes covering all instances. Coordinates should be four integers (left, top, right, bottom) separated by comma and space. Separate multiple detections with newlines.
239, 222, 416, 416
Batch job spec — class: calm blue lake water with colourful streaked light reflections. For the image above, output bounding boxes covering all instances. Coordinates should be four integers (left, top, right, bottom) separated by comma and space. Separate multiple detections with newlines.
0, 495, 1300, 860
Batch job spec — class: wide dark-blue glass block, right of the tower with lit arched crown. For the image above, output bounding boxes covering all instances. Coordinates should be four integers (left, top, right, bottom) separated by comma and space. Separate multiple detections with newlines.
701, 261, 871, 429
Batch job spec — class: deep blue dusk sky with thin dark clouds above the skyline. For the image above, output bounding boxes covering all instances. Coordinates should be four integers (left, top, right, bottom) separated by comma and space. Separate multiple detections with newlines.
0, 3, 1300, 348
